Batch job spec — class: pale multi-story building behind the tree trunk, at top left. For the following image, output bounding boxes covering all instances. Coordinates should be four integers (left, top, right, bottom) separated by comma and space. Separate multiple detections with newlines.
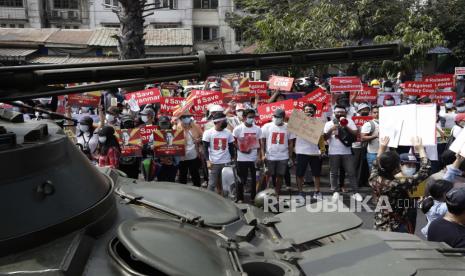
0, 0, 240, 53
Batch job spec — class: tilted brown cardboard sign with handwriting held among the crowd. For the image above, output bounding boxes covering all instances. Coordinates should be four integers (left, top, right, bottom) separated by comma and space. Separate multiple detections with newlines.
287, 110, 325, 145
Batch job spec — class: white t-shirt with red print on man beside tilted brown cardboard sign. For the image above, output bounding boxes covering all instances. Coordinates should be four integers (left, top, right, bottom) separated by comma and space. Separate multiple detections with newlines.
262, 122, 292, 161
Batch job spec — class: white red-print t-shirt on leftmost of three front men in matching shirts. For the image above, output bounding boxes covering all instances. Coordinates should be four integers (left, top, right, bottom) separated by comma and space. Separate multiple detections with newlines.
202, 128, 234, 164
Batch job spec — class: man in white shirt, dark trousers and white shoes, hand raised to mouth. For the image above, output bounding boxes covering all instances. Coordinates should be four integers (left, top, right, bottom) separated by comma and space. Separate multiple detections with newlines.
323, 105, 363, 201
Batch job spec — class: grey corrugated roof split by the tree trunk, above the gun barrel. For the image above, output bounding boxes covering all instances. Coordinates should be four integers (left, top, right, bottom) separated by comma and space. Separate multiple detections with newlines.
88, 28, 193, 47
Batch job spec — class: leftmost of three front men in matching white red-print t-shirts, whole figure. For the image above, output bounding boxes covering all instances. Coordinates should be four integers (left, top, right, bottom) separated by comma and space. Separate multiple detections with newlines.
202, 113, 234, 195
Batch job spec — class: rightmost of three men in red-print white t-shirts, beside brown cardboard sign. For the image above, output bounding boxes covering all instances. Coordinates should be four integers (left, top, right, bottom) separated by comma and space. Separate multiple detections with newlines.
261, 109, 293, 195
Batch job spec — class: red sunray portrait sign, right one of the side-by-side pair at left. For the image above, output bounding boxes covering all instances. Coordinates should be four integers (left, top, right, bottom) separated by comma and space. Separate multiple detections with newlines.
153, 128, 185, 156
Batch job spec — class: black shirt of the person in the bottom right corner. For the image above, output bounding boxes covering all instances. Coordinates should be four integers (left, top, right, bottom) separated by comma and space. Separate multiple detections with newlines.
428, 218, 465, 248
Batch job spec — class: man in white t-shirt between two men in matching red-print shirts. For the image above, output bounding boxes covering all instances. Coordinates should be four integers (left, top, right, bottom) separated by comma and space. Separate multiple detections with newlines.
233, 109, 262, 202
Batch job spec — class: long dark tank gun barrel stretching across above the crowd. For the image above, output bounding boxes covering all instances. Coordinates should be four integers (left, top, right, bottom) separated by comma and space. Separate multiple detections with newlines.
0, 44, 405, 101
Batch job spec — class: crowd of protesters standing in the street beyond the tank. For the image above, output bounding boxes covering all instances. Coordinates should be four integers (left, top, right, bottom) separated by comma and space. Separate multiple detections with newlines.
6, 73, 465, 247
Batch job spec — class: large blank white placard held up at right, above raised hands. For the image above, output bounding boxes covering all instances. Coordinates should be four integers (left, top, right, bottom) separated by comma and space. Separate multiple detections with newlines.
379, 104, 436, 147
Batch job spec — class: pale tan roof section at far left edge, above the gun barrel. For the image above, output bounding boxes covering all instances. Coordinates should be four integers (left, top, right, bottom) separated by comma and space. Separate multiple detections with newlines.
0, 28, 58, 44
